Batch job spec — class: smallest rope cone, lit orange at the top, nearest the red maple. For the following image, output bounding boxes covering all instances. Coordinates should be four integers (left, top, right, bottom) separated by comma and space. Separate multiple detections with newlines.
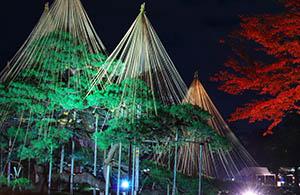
178, 72, 258, 179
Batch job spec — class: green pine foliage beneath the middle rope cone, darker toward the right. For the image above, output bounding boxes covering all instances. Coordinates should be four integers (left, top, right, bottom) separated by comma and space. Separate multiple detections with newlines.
94, 79, 230, 152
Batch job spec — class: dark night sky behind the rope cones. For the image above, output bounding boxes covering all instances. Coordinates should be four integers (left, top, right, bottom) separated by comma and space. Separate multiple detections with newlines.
0, 0, 281, 133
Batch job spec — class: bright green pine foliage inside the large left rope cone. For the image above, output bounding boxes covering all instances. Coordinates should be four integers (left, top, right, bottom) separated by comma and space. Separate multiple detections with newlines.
0, 31, 110, 163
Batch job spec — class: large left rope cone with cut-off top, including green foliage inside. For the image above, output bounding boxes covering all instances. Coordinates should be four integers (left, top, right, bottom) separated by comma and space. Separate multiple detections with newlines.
0, 0, 106, 186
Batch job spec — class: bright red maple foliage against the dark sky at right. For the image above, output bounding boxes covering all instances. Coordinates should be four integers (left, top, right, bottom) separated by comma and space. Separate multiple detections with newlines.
211, 0, 300, 135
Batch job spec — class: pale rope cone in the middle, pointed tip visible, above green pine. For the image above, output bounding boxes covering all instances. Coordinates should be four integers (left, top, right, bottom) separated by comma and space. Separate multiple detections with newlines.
91, 5, 187, 112
